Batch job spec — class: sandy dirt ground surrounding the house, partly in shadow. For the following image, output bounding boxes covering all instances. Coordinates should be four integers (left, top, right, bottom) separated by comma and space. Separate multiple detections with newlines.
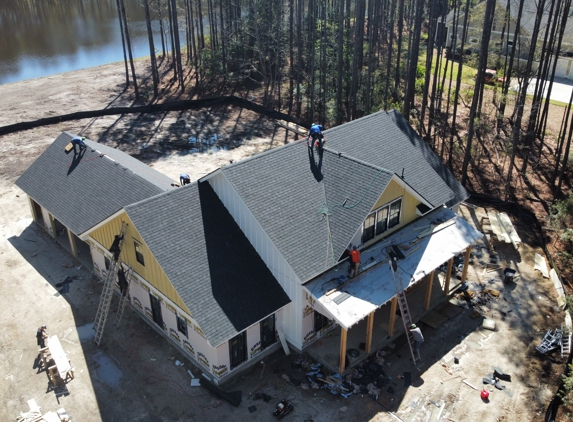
0, 64, 564, 422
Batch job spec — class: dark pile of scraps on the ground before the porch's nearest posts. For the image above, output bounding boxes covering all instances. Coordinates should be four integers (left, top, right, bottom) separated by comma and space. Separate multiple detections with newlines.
290, 350, 392, 400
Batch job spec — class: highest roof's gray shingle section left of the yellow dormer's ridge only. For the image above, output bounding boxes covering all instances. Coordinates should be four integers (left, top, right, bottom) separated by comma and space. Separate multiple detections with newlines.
222, 142, 393, 282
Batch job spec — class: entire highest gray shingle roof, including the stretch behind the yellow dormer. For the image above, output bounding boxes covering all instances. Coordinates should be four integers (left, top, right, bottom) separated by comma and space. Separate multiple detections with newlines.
222, 112, 468, 283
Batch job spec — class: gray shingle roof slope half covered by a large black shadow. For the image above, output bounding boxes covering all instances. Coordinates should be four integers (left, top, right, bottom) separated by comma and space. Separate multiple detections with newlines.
125, 182, 290, 347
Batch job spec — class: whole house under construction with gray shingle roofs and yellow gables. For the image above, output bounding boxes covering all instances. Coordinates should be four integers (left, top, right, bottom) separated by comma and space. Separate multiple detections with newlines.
16, 111, 482, 383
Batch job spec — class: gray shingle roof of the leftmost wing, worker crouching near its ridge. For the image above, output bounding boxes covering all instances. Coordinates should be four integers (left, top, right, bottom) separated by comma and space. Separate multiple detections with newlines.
16, 132, 173, 235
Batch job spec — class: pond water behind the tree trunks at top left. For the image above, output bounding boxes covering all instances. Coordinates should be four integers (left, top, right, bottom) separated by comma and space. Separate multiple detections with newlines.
0, 0, 179, 84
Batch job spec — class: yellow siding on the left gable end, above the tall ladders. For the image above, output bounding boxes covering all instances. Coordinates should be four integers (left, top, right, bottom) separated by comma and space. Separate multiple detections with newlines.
90, 212, 192, 315
